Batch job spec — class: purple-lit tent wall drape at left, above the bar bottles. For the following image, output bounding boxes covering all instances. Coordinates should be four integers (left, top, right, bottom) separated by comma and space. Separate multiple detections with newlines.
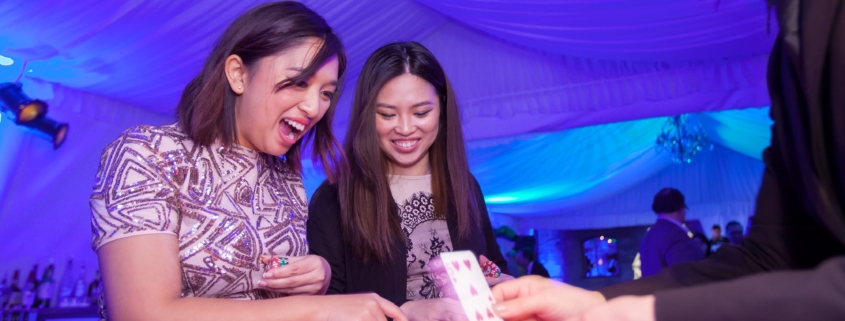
0, 83, 172, 278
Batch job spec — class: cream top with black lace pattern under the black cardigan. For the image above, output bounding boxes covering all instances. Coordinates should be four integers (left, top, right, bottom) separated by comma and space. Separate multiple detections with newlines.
389, 174, 453, 301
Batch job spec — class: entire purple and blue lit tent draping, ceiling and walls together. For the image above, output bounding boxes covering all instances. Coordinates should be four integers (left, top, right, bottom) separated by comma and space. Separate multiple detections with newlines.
0, 0, 777, 270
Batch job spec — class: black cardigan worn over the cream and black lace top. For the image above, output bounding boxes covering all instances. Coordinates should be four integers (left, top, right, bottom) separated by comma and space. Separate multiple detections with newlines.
307, 179, 508, 305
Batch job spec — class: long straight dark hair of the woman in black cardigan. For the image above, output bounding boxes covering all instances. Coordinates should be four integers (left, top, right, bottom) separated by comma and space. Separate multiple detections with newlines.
338, 42, 480, 263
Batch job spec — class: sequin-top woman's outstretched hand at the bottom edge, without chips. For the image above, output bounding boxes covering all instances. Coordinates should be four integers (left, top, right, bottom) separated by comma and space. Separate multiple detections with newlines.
316, 293, 408, 321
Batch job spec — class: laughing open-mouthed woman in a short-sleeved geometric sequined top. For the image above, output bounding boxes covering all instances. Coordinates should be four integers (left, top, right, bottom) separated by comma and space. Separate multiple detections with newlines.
91, 2, 405, 320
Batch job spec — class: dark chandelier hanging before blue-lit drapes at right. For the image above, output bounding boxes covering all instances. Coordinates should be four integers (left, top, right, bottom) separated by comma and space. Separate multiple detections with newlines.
657, 114, 713, 164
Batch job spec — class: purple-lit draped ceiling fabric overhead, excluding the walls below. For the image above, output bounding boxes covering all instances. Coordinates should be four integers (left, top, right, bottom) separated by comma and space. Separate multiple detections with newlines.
0, 0, 775, 139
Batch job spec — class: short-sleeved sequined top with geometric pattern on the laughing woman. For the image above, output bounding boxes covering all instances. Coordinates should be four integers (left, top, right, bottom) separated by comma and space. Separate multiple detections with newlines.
91, 124, 308, 300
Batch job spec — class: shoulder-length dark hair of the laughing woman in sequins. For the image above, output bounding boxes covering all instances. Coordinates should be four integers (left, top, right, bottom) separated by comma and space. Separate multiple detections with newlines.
176, 1, 346, 177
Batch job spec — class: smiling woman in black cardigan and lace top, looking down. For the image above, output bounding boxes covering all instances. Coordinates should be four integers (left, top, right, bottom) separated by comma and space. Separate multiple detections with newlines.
308, 42, 508, 319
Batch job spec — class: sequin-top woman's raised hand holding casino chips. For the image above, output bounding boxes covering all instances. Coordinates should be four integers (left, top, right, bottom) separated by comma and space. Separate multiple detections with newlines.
258, 255, 332, 295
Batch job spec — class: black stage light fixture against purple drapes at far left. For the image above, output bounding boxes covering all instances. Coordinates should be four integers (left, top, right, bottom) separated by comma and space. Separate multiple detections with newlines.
0, 82, 68, 149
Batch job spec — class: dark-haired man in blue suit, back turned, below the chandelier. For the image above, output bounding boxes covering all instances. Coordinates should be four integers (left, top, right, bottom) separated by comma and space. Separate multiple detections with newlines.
640, 187, 704, 277
